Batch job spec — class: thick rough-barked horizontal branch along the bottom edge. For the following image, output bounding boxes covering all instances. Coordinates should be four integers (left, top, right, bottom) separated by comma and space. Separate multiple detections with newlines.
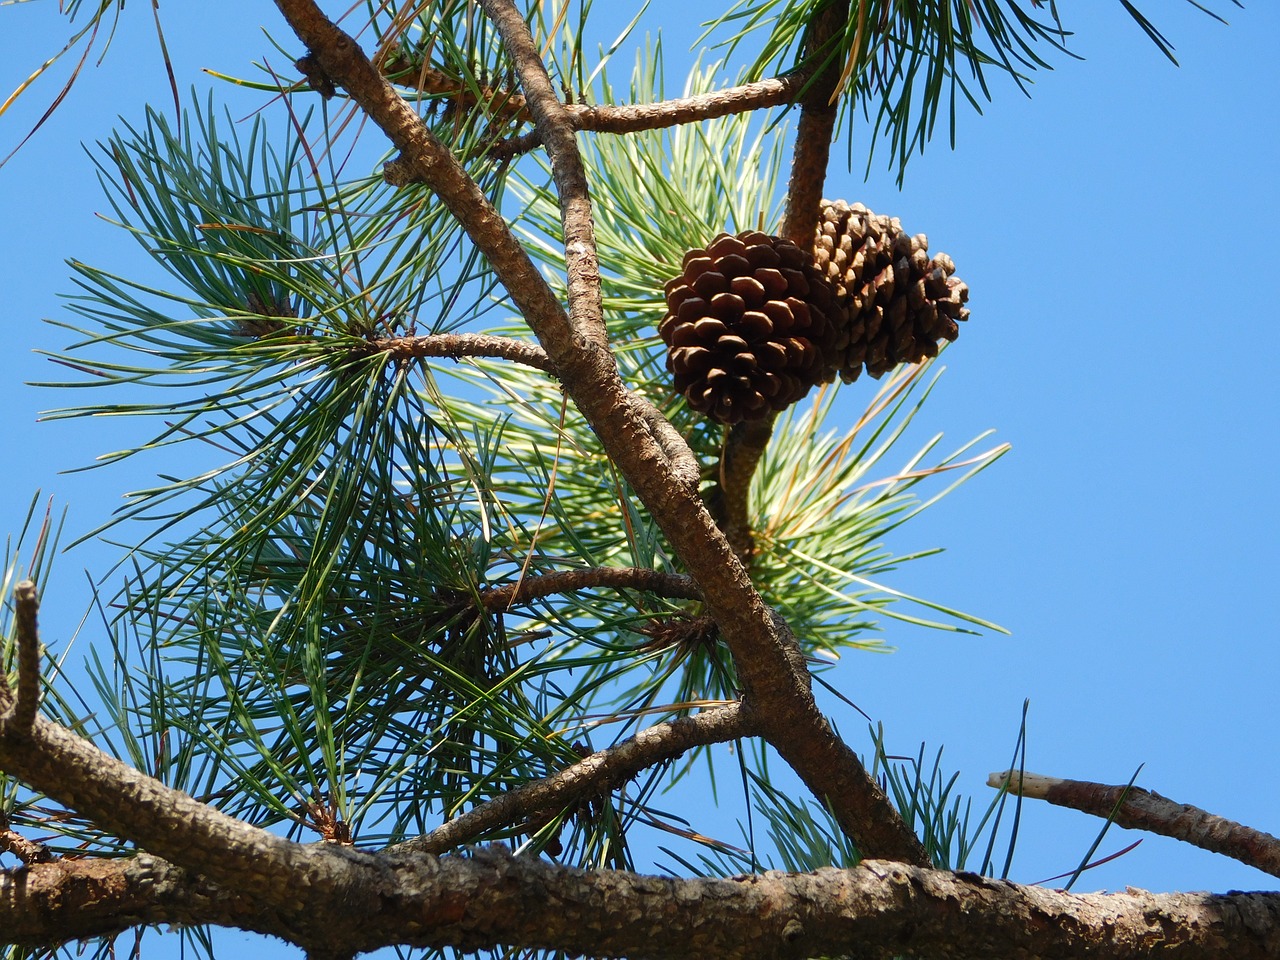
0, 845, 1280, 960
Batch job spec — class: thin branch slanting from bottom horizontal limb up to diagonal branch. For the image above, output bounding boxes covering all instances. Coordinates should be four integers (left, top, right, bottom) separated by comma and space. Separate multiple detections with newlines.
388, 703, 755, 855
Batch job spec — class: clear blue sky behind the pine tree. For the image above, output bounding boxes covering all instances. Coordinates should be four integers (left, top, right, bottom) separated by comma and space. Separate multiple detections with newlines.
0, 0, 1280, 947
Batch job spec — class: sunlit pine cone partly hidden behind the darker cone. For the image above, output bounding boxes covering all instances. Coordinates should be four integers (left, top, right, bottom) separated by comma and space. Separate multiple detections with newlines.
814, 200, 969, 383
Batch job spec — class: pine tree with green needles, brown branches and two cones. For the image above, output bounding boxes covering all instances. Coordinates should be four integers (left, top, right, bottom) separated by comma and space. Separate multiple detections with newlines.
0, 0, 1280, 957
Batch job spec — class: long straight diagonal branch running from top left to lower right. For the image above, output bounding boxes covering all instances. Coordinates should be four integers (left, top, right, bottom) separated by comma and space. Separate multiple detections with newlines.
276, 0, 928, 864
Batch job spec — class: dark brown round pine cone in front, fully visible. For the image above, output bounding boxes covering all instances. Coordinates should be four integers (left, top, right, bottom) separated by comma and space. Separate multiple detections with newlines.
658, 232, 845, 424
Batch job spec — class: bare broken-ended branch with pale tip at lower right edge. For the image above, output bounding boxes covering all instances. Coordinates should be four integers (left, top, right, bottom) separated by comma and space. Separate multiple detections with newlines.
987, 771, 1280, 877
